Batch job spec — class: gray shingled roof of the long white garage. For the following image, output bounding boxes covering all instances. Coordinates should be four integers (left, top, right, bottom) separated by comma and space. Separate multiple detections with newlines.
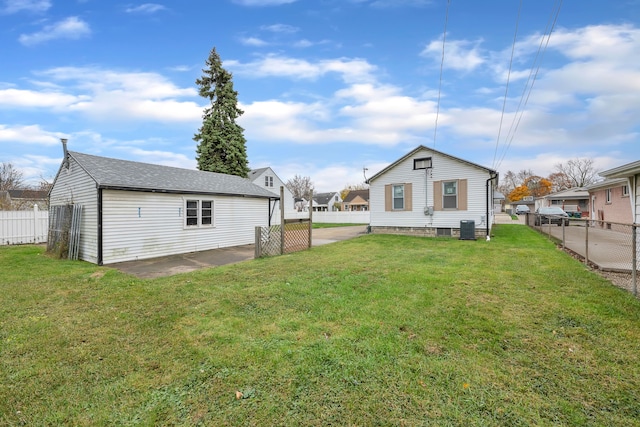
69, 151, 273, 198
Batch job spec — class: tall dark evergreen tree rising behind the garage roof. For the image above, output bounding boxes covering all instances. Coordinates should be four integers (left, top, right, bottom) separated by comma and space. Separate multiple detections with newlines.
193, 47, 249, 178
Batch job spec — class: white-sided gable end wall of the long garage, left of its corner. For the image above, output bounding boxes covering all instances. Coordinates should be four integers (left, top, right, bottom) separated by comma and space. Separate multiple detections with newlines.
49, 158, 98, 264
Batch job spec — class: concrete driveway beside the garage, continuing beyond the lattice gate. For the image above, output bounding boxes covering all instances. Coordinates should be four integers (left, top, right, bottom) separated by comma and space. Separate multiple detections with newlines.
108, 225, 367, 279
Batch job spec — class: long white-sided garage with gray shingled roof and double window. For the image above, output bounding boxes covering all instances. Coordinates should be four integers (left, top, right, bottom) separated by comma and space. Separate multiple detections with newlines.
49, 144, 275, 265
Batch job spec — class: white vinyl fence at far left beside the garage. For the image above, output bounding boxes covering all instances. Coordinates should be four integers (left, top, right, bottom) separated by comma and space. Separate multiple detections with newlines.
0, 206, 49, 245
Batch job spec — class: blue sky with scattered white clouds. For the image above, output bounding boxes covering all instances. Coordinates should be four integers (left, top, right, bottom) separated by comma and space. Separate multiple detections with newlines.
0, 0, 640, 191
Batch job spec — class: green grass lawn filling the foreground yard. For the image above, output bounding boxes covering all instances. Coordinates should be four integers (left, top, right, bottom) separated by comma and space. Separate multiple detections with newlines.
0, 225, 640, 426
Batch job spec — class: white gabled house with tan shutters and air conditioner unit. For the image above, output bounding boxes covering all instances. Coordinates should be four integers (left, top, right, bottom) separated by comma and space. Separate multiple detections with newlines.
367, 145, 498, 238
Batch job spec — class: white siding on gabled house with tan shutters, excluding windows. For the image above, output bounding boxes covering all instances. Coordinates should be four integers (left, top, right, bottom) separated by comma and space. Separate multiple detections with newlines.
369, 149, 493, 229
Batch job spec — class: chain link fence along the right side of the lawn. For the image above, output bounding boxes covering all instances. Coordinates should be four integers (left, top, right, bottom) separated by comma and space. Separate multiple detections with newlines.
526, 214, 640, 296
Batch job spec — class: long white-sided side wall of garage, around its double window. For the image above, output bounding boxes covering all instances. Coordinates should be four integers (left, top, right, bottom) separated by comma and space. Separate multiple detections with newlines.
102, 190, 268, 264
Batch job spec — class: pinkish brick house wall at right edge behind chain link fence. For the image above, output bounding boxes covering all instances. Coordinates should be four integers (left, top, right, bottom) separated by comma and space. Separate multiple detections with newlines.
587, 178, 633, 224
